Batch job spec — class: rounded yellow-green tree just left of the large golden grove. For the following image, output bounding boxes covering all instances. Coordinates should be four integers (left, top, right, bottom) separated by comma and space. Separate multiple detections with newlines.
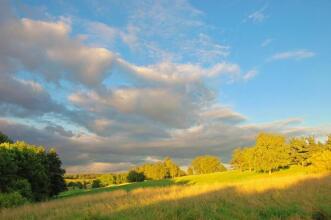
191, 155, 226, 174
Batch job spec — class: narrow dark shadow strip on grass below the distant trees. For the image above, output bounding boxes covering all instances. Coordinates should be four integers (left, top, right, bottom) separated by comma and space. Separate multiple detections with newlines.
58, 179, 192, 199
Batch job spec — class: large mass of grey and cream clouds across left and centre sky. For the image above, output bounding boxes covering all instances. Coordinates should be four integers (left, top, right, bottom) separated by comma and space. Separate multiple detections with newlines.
0, 0, 326, 172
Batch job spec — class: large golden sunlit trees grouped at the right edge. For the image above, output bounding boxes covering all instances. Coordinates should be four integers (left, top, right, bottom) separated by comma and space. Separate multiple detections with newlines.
231, 133, 331, 173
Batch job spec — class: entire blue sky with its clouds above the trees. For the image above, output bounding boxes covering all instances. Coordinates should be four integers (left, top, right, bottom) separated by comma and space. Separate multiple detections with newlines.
0, 0, 331, 173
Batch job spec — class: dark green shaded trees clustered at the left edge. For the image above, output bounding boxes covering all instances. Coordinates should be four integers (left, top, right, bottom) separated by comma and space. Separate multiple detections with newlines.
0, 132, 66, 207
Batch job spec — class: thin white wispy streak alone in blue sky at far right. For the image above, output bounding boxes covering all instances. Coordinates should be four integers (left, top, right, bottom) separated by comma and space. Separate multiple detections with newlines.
268, 49, 316, 61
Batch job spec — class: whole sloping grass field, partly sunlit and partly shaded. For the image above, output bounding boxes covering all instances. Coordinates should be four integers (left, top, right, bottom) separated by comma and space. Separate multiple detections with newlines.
0, 168, 331, 219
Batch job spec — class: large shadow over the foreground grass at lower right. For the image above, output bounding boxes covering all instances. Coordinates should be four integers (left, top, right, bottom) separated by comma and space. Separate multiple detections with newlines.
94, 175, 331, 220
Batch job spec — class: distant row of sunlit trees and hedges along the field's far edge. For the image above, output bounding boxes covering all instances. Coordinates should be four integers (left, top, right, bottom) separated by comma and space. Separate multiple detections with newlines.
65, 155, 226, 189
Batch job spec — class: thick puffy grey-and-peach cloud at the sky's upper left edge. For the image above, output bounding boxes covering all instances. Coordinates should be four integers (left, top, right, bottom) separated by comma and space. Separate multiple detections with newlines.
0, 18, 115, 86
